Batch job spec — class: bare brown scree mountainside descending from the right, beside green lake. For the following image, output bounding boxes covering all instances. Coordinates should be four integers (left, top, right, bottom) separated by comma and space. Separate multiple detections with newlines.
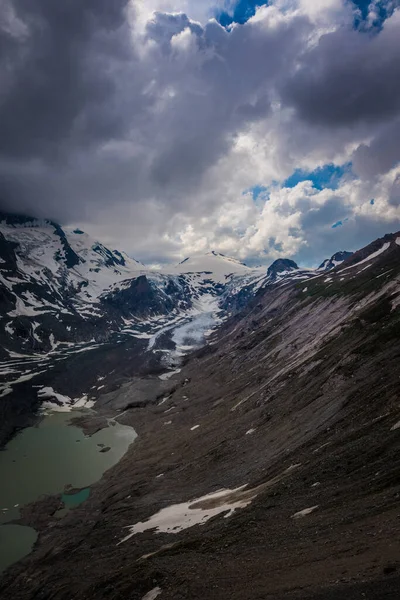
0, 233, 400, 600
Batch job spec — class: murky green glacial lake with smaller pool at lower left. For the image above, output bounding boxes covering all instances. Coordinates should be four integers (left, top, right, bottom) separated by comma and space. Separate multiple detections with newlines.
0, 411, 136, 571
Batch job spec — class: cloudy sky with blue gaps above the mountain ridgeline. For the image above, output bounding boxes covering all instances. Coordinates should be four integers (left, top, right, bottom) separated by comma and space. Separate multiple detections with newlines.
0, 0, 400, 266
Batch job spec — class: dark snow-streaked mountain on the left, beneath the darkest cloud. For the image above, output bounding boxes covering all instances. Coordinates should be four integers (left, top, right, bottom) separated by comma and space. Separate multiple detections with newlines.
0, 215, 196, 353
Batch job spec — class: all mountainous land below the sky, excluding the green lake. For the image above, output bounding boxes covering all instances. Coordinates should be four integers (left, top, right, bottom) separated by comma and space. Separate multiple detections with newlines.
0, 214, 400, 600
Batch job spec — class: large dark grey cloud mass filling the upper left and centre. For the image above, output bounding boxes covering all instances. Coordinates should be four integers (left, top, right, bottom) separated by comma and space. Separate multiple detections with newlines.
0, 0, 310, 221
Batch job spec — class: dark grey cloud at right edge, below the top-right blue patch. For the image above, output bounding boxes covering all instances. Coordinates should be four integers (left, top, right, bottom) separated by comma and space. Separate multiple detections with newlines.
282, 15, 400, 127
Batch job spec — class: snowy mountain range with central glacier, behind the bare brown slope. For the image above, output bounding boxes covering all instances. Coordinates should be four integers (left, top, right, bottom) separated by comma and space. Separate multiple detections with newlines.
0, 215, 400, 446
